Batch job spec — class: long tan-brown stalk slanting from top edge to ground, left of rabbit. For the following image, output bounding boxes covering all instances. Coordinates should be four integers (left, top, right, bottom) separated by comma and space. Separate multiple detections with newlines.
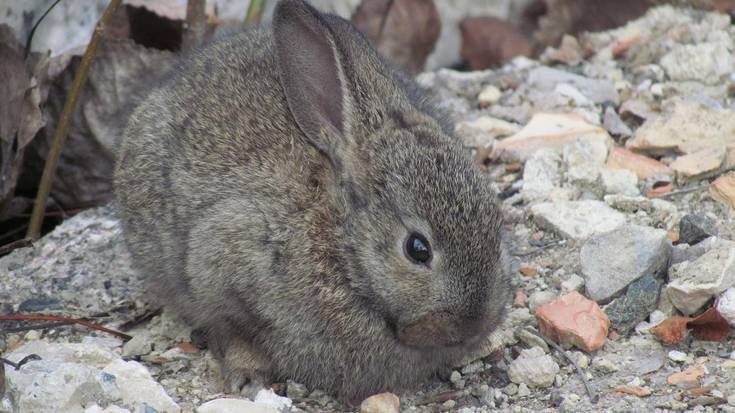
26, 0, 122, 240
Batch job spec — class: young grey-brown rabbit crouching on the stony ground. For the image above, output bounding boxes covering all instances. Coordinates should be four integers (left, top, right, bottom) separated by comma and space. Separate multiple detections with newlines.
115, 0, 510, 401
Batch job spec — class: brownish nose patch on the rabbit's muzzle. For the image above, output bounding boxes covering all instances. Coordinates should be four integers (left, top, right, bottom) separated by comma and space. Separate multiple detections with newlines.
398, 311, 467, 347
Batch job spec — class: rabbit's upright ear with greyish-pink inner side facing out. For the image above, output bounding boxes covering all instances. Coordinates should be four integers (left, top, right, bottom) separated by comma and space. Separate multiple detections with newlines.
273, 0, 349, 166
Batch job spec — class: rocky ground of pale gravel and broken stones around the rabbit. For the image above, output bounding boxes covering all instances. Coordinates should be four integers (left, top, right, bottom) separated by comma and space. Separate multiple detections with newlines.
0, 7, 735, 412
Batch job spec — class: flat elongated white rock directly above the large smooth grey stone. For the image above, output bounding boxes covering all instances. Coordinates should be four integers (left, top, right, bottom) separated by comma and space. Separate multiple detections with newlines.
531, 200, 625, 240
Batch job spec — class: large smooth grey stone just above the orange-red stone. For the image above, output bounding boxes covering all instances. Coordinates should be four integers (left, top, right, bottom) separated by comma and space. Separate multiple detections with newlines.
580, 224, 671, 302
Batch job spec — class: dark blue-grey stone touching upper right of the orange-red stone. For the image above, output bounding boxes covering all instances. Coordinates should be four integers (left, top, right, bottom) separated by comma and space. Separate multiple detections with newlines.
604, 275, 663, 334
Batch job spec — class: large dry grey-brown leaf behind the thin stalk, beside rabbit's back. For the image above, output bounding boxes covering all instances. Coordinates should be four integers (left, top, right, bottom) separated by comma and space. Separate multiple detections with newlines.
19, 39, 175, 209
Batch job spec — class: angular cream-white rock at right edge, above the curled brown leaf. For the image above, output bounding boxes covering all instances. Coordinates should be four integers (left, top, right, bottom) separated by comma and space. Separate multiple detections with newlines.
665, 237, 735, 315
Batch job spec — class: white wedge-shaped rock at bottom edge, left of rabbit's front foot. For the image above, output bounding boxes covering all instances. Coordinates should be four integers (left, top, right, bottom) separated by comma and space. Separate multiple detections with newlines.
102, 359, 181, 412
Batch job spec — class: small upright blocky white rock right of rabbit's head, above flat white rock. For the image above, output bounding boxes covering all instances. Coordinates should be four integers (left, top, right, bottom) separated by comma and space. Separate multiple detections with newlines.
521, 149, 562, 203
